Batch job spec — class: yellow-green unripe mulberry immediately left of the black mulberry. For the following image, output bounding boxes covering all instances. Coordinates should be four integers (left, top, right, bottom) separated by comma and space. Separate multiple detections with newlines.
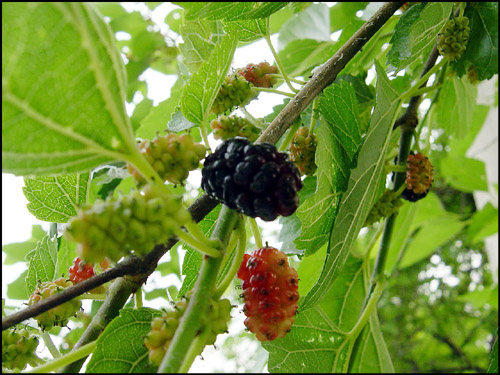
127, 133, 206, 185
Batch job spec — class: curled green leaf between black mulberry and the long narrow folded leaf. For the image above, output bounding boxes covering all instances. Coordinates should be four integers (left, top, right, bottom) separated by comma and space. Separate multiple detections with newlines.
295, 81, 361, 255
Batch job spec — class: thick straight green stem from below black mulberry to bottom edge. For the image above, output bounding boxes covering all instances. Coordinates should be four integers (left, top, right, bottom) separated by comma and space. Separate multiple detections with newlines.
158, 205, 238, 373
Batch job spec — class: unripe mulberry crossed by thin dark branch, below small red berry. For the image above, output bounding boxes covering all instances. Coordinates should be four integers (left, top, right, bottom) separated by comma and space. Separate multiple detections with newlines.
28, 277, 82, 331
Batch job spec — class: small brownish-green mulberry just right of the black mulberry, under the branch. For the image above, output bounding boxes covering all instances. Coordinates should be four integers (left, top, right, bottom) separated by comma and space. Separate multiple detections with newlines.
290, 126, 317, 176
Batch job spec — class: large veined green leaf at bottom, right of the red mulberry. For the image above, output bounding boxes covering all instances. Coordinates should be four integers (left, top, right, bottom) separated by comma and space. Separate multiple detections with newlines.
262, 255, 394, 373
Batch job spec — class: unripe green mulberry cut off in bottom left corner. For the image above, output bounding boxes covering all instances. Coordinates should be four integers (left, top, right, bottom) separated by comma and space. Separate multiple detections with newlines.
2, 329, 38, 370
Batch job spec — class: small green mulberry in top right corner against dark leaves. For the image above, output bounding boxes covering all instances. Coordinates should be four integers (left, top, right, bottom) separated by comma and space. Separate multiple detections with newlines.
438, 17, 470, 61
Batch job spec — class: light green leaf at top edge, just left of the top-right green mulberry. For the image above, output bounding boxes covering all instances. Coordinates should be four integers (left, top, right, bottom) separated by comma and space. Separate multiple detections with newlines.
409, 2, 453, 62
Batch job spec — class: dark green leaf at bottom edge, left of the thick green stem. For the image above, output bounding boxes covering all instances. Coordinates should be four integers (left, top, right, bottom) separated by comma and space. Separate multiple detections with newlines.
87, 307, 161, 373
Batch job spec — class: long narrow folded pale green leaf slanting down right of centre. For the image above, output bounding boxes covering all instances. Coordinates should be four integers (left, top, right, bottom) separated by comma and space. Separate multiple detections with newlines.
302, 62, 401, 310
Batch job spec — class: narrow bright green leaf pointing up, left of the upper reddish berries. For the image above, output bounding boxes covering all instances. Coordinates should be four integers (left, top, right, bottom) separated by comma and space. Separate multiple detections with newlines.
181, 34, 238, 124
